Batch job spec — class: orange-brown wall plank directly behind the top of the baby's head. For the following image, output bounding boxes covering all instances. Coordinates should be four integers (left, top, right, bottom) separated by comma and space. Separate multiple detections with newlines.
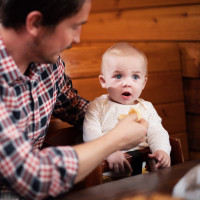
61, 43, 181, 78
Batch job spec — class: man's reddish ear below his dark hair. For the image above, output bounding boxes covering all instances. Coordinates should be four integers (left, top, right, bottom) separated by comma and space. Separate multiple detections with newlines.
26, 11, 43, 36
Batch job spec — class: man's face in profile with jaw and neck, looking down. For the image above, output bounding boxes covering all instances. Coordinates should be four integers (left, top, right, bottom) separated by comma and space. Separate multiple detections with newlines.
30, 0, 91, 63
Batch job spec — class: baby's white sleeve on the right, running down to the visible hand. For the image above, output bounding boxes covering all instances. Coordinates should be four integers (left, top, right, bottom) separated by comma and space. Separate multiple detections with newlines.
147, 102, 171, 155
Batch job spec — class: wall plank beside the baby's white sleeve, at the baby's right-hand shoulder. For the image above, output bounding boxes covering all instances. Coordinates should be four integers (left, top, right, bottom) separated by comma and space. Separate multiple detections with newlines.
155, 102, 186, 134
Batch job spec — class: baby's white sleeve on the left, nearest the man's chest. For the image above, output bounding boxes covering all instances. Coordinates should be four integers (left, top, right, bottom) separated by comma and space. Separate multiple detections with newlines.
83, 98, 103, 142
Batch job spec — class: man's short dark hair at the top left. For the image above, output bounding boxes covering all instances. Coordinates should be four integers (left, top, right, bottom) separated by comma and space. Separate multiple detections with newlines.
0, 0, 85, 29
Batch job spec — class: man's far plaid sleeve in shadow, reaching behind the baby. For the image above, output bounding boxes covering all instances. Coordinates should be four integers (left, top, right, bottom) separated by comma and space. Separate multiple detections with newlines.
53, 60, 89, 127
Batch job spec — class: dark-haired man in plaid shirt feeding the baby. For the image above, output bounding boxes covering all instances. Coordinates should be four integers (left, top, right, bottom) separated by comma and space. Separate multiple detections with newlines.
0, 0, 147, 199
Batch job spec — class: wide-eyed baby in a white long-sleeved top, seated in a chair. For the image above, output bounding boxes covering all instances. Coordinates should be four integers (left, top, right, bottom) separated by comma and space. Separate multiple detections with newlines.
83, 43, 171, 175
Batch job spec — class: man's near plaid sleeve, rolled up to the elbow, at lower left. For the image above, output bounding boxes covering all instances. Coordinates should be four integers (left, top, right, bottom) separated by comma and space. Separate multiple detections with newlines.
0, 101, 78, 199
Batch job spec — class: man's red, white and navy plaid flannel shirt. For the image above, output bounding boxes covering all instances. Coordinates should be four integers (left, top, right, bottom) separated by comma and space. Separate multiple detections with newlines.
0, 37, 88, 199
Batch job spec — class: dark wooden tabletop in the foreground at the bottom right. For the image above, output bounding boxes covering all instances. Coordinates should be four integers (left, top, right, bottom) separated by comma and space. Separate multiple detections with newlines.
56, 160, 200, 200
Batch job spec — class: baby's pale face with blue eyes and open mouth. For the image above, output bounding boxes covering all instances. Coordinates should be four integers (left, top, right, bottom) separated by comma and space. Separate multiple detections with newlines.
101, 55, 147, 105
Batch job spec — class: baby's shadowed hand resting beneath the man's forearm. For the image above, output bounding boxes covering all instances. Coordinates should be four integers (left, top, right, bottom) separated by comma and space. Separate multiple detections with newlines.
107, 151, 133, 175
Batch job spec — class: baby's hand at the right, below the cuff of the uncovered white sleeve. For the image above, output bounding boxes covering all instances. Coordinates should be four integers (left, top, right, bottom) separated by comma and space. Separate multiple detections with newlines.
148, 150, 171, 169
